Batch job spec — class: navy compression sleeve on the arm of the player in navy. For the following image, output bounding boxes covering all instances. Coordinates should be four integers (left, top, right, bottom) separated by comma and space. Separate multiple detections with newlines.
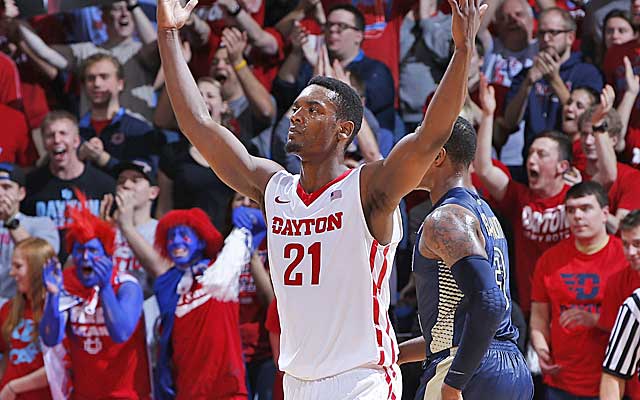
444, 256, 508, 390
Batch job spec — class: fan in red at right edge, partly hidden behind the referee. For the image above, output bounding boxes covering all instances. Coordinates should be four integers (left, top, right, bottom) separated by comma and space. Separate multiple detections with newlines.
598, 210, 640, 400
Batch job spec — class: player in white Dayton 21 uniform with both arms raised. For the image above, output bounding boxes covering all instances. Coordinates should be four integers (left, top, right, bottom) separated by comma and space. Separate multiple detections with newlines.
158, 0, 486, 400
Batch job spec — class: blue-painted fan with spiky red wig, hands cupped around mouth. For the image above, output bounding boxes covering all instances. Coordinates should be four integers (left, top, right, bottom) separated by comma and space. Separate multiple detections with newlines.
40, 190, 151, 400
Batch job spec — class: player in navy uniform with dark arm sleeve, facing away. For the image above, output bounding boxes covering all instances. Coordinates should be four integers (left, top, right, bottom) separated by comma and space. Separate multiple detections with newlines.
399, 118, 533, 400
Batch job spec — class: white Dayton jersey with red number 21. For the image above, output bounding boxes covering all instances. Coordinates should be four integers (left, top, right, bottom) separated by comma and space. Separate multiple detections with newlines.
264, 168, 402, 380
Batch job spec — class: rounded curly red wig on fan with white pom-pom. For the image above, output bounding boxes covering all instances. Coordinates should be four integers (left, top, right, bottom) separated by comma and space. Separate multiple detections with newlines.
155, 208, 223, 260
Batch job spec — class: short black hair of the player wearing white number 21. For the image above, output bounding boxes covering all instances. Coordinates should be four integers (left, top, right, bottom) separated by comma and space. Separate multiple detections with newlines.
309, 76, 364, 149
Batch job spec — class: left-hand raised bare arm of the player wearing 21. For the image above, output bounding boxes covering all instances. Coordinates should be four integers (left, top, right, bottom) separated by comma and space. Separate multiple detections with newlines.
157, 0, 282, 202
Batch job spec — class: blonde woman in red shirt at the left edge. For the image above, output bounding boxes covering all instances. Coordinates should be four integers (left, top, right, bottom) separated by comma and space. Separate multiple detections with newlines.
0, 237, 56, 400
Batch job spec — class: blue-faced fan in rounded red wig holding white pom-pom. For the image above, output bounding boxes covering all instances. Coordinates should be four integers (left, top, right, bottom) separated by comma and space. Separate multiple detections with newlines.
153, 208, 250, 400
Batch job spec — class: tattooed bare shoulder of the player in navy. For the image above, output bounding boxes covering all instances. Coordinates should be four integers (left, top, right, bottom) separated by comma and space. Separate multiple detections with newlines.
421, 205, 486, 266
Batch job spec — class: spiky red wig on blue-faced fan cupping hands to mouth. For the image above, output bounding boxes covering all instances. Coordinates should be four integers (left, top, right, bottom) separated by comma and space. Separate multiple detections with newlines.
64, 188, 116, 255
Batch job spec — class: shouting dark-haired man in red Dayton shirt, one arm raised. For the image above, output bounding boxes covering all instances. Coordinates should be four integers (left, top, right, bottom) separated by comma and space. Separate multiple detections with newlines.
473, 78, 571, 315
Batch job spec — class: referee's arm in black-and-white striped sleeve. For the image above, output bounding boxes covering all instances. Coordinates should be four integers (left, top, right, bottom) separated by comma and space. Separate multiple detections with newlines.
600, 290, 640, 400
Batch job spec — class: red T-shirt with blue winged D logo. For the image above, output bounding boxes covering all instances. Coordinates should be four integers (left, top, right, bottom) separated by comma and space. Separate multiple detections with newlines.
531, 236, 627, 396
